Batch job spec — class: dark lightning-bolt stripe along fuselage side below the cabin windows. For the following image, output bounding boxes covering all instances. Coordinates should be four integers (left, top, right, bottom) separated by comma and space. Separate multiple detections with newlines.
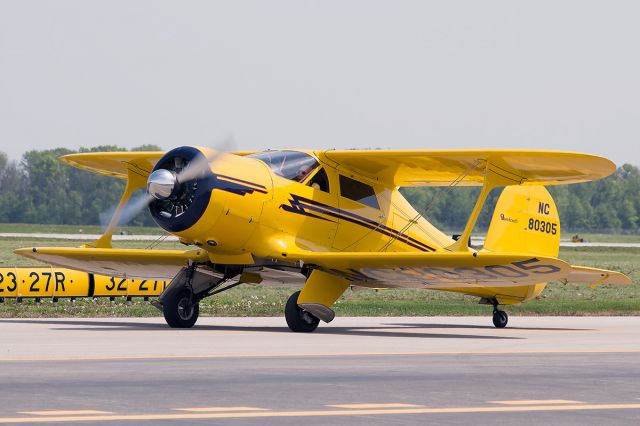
280, 194, 436, 251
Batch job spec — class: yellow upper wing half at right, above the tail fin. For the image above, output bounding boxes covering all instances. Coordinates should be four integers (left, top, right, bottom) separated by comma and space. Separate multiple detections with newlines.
319, 149, 616, 186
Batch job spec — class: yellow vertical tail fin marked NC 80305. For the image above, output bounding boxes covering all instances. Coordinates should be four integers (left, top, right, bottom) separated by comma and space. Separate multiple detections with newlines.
484, 185, 560, 257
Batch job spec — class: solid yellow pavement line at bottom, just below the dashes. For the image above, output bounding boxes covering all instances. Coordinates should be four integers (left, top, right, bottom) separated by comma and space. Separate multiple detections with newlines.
0, 404, 640, 423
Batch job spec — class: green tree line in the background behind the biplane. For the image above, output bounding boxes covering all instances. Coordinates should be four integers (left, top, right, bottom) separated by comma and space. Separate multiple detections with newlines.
0, 145, 640, 233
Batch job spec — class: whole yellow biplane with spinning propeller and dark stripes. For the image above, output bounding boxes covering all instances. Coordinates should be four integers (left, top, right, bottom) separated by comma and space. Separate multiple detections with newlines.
16, 147, 630, 332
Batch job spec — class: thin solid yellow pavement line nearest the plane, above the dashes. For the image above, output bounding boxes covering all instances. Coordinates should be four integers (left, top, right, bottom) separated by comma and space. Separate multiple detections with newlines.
0, 348, 640, 362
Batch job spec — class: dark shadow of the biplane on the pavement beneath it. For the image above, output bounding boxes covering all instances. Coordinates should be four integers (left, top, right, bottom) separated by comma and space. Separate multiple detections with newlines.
0, 318, 540, 340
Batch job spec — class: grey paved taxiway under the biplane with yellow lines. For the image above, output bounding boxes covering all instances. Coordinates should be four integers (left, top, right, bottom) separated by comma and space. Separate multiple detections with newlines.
0, 317, 640, 425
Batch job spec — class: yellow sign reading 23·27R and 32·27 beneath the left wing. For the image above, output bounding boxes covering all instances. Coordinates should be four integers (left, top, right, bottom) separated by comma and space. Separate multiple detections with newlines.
0, 267, 169, 298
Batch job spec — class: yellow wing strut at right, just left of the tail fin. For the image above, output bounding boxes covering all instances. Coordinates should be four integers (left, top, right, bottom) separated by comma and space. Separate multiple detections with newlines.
446, 160, 526, 251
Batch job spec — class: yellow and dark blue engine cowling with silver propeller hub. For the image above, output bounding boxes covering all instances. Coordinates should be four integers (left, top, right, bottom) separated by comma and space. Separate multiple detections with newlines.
147, 146, 273, 252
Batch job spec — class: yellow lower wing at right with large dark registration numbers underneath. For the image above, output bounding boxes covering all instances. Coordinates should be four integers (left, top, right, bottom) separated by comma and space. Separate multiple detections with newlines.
287, 252, 571, 288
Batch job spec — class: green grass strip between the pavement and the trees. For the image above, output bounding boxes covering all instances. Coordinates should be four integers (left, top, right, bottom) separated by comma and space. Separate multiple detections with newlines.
0, 238, 640, 317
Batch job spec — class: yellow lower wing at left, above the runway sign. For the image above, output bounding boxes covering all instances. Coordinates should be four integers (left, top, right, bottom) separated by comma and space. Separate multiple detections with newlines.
15, 247, 209, 279
